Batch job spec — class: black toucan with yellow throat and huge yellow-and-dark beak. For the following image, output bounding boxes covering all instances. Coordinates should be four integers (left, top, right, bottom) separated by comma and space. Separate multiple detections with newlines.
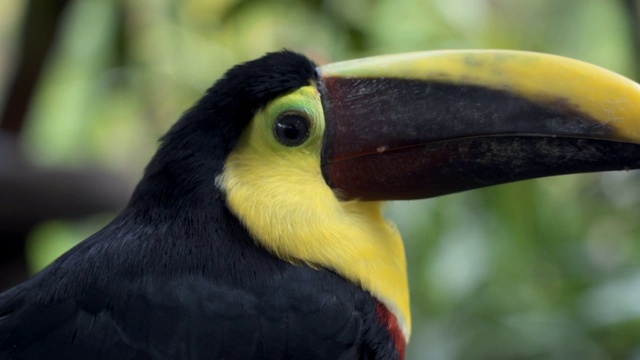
0, 50, 640, 360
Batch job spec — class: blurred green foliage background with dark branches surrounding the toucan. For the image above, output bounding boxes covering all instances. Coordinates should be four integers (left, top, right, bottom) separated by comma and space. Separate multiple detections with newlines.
0, 0, 640, 360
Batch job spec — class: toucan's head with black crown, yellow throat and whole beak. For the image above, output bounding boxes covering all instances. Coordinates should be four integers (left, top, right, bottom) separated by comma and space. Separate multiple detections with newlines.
132, 51, 640, 338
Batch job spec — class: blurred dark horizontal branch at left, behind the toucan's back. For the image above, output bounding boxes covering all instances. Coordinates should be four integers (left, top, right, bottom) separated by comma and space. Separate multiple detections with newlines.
0, 132, 131, 291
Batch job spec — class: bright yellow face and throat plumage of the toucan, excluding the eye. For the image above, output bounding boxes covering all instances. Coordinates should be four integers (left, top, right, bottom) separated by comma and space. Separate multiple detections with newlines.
217, 86, 411, 340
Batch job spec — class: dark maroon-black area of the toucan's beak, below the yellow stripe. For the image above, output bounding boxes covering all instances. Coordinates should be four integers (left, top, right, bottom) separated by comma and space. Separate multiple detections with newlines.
320, 78, 640, 200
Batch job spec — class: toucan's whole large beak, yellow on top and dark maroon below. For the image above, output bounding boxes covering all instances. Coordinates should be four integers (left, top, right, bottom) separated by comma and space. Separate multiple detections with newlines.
319, 51, 640, 200
